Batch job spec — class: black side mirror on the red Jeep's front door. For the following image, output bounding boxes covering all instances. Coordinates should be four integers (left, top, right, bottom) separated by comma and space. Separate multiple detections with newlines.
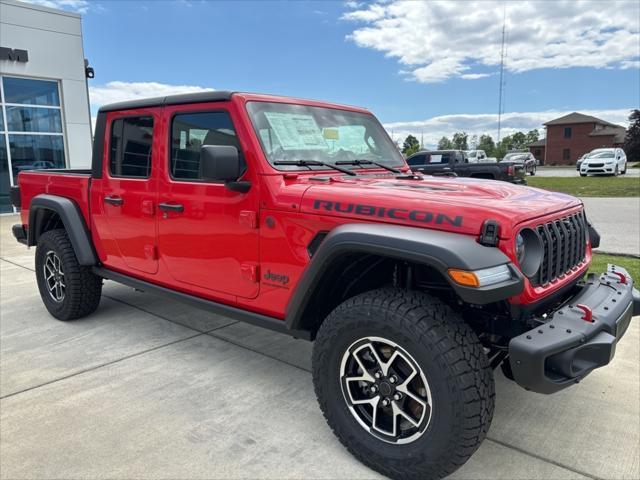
200, 145, 251, 193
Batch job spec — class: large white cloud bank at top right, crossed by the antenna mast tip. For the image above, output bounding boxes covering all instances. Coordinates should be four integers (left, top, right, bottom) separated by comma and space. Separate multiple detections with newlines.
342, 0, 640, 83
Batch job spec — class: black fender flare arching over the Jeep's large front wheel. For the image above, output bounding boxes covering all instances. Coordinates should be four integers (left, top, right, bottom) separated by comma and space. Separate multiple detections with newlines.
285, 223, 524, 330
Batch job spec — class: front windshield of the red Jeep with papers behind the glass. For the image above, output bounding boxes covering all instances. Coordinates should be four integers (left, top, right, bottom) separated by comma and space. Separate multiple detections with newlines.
247, 102, 404, 170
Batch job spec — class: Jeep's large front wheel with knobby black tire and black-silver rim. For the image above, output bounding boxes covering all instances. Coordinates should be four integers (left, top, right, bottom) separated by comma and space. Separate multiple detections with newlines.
313, 289, 495, 479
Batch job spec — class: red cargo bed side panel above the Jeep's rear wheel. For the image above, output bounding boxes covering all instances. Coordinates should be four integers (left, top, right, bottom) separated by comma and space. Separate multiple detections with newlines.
18, 170, 91, 226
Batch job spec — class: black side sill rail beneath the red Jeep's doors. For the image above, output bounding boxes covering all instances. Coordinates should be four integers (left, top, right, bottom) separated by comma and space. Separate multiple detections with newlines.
93, 267, 311, 340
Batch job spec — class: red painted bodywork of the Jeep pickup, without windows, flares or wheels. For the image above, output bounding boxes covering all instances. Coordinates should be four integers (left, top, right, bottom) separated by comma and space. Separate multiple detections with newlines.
19, 94, 591, 318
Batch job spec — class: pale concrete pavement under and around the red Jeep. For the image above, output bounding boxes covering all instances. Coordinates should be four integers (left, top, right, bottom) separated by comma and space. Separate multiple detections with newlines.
0, 216, 640, 479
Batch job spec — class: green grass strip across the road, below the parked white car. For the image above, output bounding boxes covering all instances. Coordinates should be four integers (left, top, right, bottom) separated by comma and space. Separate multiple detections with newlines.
527, 177, 640, 197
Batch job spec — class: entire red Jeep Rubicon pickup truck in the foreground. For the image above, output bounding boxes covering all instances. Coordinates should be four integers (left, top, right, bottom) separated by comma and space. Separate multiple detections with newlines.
12, 91, 640, 479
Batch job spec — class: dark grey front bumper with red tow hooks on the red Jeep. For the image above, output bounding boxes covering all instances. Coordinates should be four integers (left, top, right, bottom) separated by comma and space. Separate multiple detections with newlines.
509, 265, 640, 393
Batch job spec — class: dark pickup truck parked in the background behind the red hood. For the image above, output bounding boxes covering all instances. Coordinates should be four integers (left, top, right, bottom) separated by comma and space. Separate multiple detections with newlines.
407, 150, 527, 184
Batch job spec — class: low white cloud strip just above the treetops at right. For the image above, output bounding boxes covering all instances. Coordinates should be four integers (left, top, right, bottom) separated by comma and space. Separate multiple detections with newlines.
384, 108, 631, 148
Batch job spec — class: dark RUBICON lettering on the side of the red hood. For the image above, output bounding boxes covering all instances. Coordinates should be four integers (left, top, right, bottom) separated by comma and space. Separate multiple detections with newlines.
313, 200, 462, 227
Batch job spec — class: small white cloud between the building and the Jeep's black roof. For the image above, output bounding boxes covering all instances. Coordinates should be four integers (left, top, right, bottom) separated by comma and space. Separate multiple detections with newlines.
89, 81, 214, 108
